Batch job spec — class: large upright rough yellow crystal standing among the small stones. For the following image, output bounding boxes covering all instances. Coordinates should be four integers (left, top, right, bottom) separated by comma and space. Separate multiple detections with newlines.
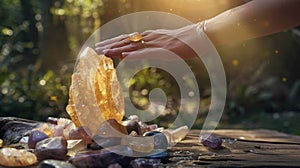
66, 47, 124, 134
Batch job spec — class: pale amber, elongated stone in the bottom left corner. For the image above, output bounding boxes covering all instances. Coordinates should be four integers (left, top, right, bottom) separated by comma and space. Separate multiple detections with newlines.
0, 148, 37, 167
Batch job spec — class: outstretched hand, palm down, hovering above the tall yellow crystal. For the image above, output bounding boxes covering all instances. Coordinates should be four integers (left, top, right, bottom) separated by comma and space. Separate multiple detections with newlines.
95, 22, 207, 59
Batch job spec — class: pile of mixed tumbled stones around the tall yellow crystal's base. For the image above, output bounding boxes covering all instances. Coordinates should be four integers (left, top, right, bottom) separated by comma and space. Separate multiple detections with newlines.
0, 116, 188, 168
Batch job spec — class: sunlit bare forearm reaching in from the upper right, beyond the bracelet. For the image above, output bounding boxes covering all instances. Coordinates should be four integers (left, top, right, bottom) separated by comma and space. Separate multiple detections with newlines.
205, 0, 300, 45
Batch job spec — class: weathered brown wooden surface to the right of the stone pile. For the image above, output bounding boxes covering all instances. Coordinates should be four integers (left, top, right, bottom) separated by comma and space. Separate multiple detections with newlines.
166, 130, 300, 168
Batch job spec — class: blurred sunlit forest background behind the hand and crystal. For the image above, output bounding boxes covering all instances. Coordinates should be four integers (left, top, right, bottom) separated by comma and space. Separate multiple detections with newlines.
0, 0, 300, 135
